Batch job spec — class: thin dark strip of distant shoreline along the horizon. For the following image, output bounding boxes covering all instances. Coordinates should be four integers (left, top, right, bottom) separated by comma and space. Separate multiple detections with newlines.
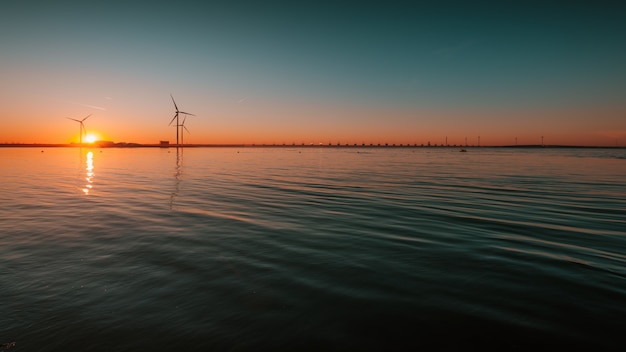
0, 143, 626, 149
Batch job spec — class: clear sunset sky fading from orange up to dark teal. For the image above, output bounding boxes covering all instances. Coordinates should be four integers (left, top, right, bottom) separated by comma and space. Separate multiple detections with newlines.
0, 0, 626, 146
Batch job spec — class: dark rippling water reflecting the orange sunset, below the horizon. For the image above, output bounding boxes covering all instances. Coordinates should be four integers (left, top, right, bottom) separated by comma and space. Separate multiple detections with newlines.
0, 147, 626, 352
